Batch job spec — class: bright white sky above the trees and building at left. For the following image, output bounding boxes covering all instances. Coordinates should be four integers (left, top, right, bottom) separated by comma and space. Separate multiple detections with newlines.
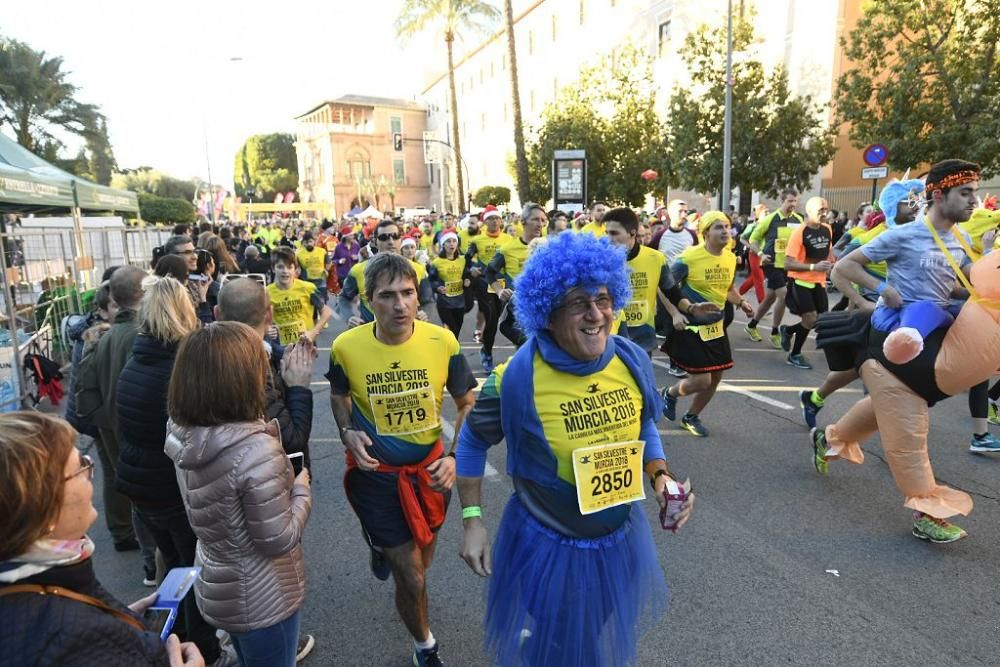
0, 0, 445, 184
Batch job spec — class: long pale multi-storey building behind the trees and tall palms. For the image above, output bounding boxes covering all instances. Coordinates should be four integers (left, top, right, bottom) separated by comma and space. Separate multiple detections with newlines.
422, 0, 884, 210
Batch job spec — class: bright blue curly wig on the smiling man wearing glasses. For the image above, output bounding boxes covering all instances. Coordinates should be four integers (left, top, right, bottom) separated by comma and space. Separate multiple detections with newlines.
514, 232, 632, 336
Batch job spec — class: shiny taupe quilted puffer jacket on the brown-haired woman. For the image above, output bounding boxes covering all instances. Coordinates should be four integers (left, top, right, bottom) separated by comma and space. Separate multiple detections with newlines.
164, 420, 312, 632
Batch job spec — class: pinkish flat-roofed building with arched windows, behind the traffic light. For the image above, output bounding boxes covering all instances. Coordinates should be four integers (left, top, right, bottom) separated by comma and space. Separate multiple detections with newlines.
295, 95, 433, 215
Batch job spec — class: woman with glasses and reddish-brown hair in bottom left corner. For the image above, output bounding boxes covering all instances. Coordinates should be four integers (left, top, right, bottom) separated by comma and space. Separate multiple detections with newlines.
0, 412, 205, 667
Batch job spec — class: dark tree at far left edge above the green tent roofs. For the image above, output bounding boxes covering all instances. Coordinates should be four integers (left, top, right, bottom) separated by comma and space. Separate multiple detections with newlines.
0, 40, 107, 155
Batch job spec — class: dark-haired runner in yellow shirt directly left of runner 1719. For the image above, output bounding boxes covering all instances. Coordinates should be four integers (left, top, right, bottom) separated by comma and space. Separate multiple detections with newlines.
267, 247, 333, 345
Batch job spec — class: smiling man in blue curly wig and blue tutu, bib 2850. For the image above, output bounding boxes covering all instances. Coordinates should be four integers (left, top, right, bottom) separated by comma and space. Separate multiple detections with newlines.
457, 234, 694, 667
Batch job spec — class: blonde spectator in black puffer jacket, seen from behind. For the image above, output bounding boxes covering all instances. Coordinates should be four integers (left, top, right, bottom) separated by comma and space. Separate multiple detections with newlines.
115, 276, 225, 663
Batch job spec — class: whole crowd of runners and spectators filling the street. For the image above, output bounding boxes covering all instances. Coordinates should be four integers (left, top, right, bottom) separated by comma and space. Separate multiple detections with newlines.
0, 160, 1000, 667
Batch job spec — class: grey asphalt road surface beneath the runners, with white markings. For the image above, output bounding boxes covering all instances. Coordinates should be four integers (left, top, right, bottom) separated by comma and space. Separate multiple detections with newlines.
92, 301, 1000, 667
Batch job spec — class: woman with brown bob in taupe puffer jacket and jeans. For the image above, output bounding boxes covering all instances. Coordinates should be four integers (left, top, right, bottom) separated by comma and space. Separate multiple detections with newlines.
165, 322, 312, 667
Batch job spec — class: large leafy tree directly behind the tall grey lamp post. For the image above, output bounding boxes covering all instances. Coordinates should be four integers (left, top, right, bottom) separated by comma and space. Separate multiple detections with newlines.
661, 14, 834, 202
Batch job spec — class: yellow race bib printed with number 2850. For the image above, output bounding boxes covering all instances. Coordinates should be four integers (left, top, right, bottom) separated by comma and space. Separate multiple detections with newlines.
573, 440, 646, 514
